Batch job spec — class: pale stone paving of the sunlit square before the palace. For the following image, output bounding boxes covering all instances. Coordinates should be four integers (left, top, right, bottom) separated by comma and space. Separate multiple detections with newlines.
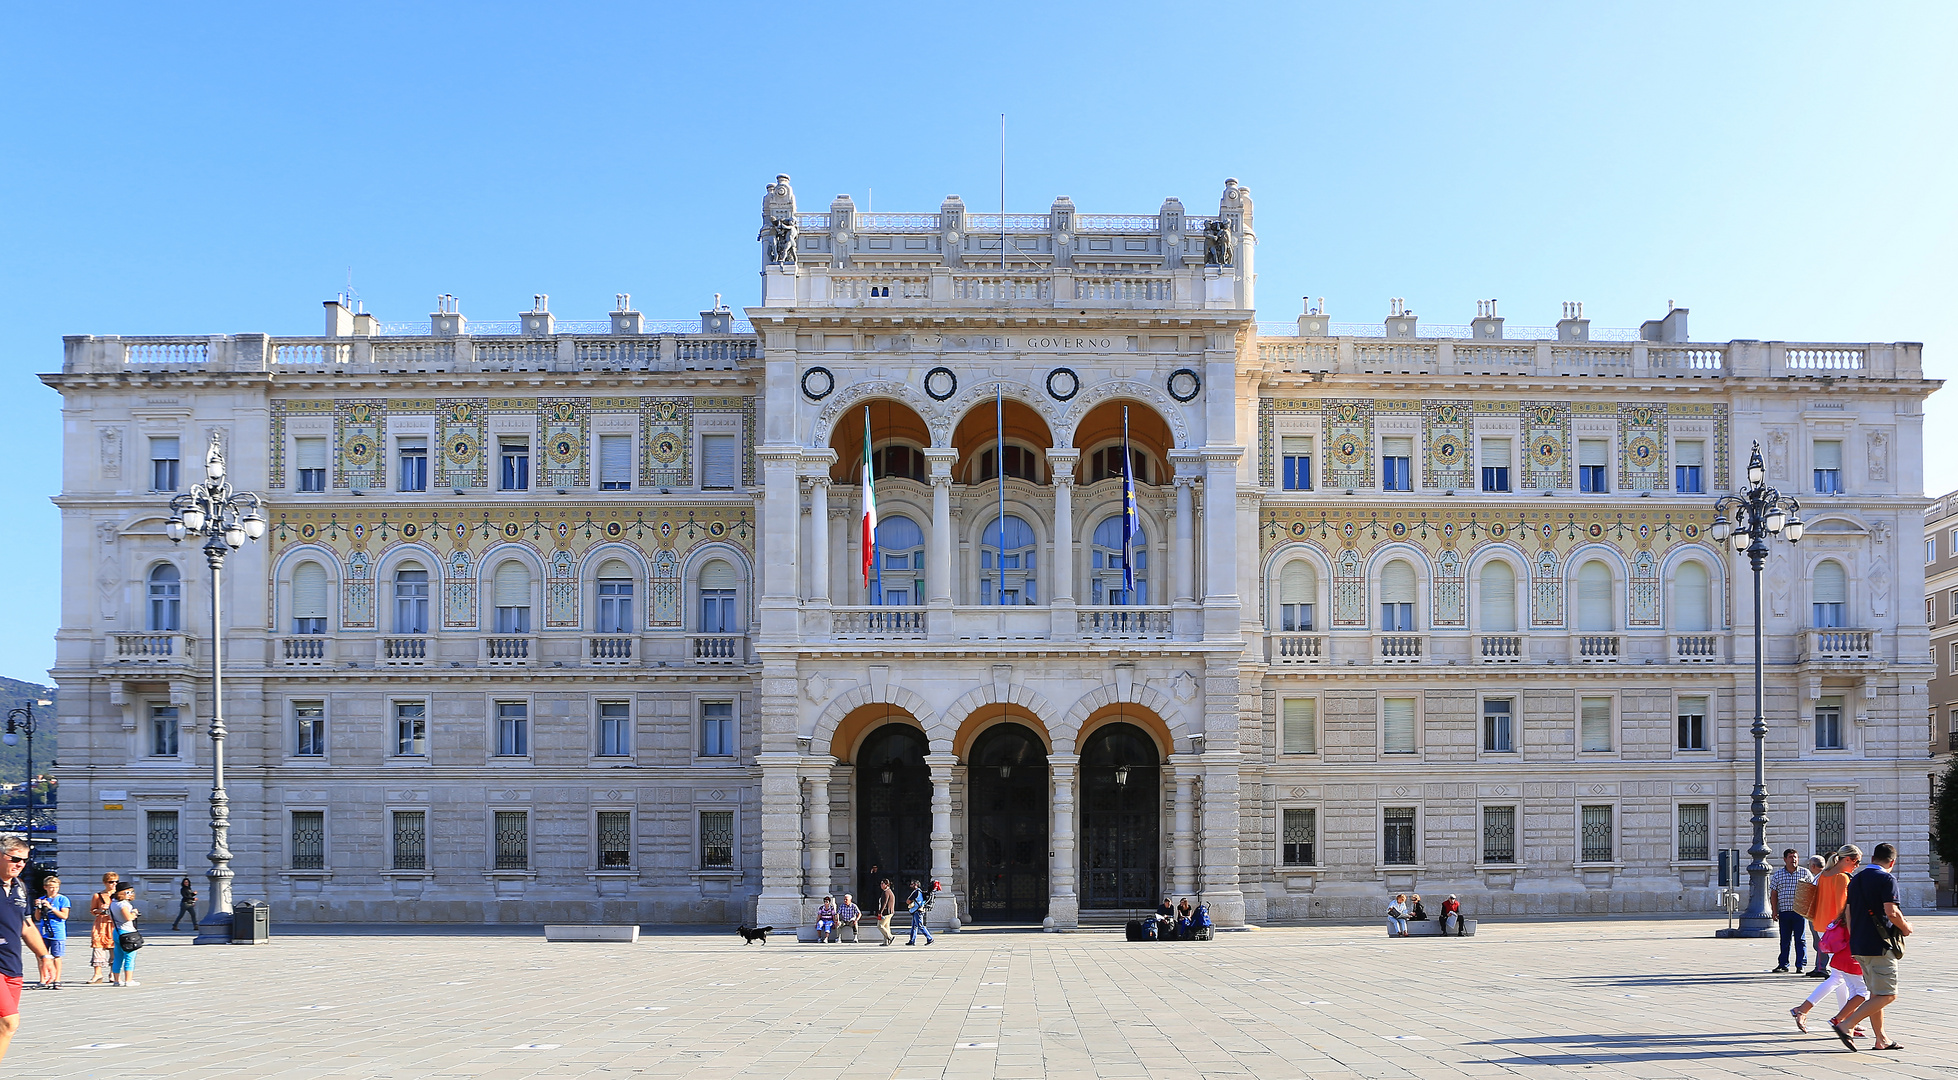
6, 914, 1958, 1080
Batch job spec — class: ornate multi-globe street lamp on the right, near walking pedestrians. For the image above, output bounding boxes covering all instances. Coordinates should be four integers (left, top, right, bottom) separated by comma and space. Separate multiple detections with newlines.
1713, 442, 1803, 937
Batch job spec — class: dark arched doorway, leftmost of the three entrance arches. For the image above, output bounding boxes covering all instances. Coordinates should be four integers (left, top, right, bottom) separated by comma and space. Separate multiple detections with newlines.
856, 724, 932, 912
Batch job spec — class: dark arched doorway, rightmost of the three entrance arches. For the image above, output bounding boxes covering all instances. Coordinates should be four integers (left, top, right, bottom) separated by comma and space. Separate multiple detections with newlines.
1081, 724, 1163, 910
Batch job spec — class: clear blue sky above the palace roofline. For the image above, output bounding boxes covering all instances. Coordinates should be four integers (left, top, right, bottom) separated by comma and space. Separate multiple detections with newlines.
0, 2, 1958, 681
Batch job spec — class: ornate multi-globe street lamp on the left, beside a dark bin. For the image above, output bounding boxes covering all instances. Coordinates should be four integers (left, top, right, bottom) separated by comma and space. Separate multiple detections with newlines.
163, 434, 264, 945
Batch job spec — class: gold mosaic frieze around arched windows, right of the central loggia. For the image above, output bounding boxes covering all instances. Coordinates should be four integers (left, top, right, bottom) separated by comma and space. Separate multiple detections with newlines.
1259, 505, 1719, 628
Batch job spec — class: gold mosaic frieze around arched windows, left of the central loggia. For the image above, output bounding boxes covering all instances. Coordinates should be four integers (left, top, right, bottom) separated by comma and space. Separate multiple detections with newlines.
266, 507, 756, 630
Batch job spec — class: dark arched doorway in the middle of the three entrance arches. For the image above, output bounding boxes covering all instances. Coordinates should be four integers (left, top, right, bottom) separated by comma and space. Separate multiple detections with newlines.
965, 724, 1049, 922
